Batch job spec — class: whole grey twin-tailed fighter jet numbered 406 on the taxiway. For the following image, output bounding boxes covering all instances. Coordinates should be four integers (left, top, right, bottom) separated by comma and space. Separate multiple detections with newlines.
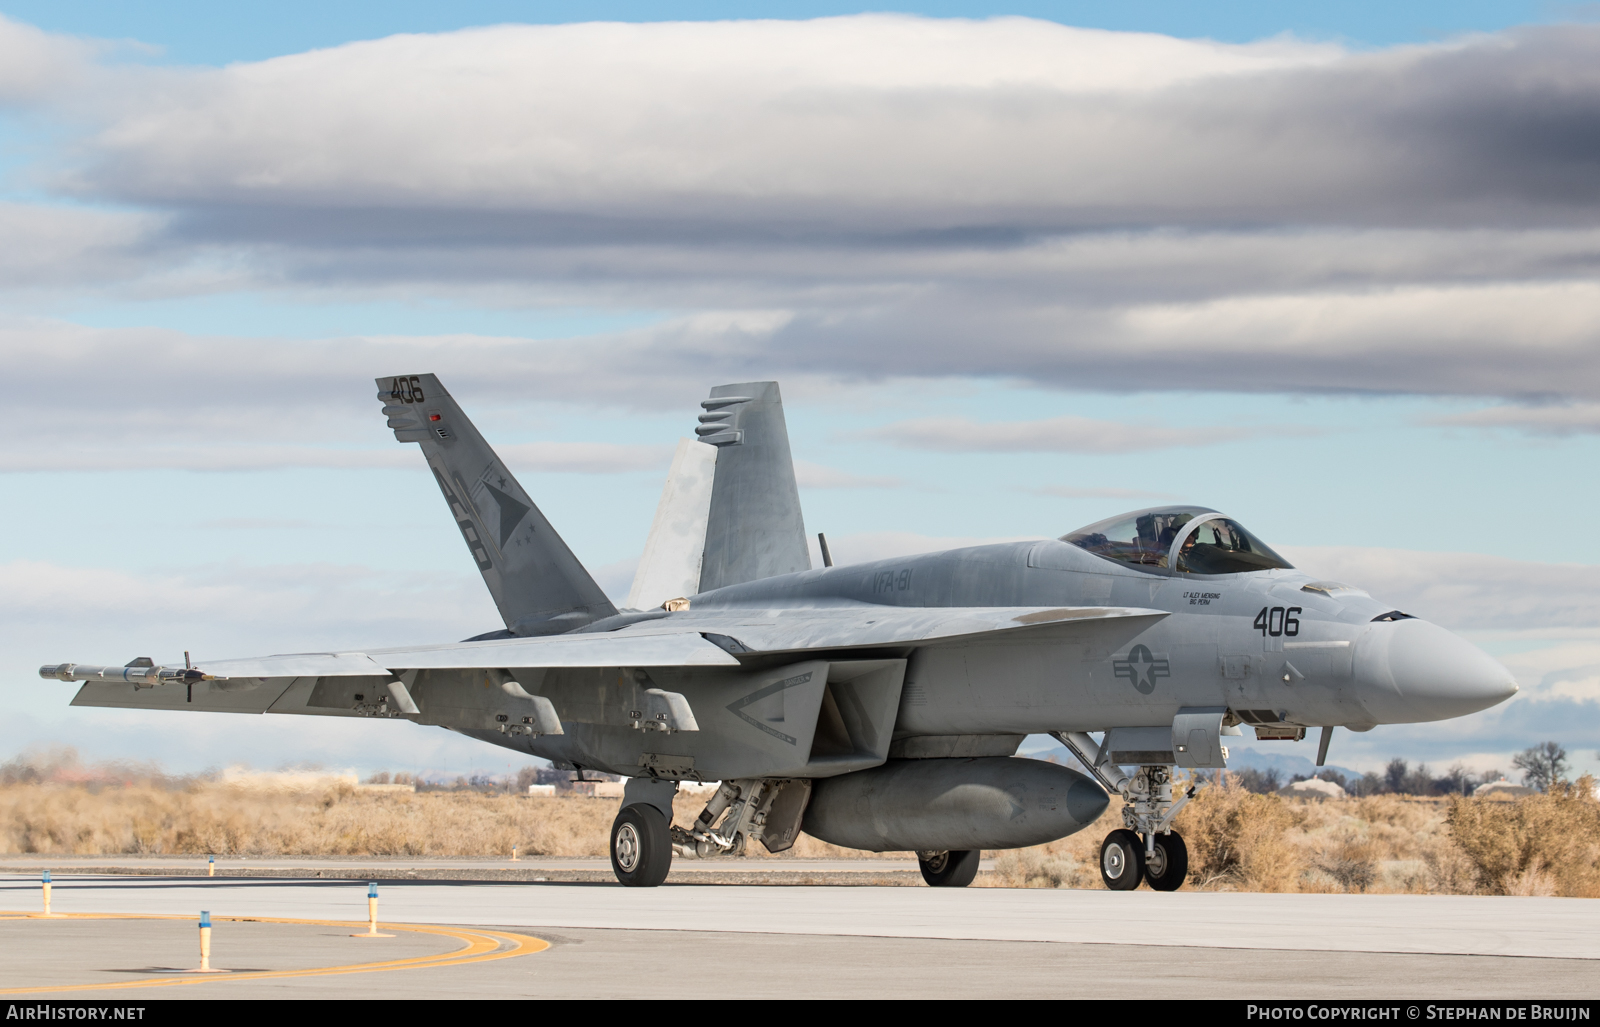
40, 374, 1517, 891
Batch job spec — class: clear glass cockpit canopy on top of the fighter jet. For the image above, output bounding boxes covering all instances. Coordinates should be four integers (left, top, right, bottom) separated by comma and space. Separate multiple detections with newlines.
1061, 507, 1293, 574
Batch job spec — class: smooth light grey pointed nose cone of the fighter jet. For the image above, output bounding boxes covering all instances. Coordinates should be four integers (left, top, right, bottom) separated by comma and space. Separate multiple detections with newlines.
1354, 621, 1517, 721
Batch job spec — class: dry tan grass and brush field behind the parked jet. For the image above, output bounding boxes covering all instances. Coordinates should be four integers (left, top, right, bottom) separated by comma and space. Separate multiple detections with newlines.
0, 764, 1600, 896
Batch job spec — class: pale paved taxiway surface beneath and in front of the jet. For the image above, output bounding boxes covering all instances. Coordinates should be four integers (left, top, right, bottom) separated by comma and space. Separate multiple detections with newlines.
0, 861, 1600, 1000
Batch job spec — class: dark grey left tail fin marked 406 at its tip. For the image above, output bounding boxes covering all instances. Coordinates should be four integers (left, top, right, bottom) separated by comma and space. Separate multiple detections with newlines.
378, 374, 616, 635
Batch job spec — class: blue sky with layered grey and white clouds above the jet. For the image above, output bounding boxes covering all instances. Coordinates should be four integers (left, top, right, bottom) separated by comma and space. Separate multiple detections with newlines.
0, 0, 1600, 773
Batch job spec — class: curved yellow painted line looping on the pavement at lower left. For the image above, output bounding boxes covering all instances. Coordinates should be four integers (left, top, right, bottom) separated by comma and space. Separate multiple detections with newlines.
0, 910, 550, 995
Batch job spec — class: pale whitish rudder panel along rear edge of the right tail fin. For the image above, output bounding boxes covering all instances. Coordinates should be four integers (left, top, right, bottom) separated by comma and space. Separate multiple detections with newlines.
626, 438, 717, 609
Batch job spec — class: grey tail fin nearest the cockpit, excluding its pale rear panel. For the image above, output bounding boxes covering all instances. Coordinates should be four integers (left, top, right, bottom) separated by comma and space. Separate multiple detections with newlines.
694, 382, 811, 592
